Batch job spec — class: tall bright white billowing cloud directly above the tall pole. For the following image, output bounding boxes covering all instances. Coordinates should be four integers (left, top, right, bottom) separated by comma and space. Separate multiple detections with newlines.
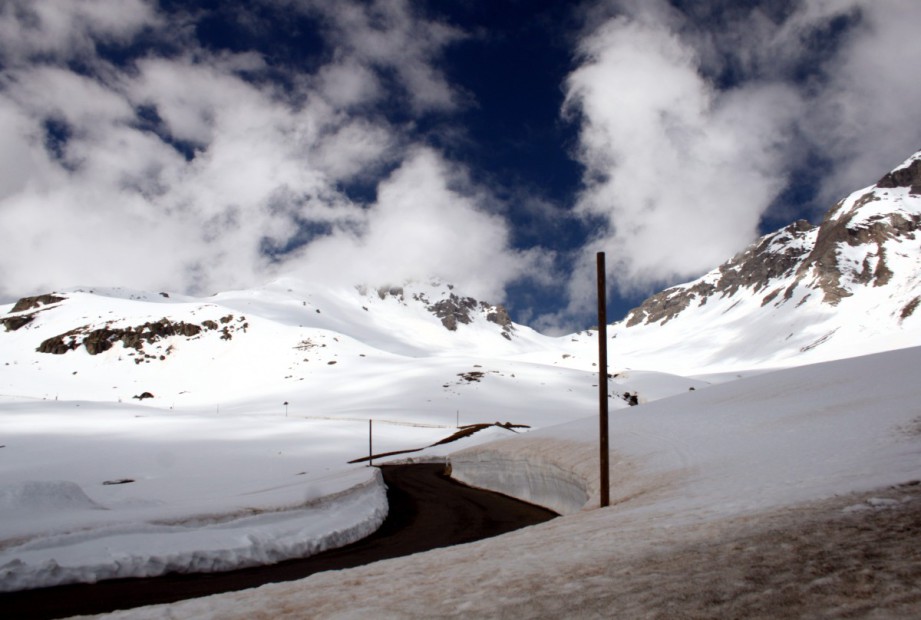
566, 9, 797, 301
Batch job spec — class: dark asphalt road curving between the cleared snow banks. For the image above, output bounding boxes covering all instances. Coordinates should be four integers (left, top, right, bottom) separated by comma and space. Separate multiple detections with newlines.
0, 464, 556, 620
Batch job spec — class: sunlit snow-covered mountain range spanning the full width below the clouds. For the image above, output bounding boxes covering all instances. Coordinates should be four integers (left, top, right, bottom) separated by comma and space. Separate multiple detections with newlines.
0, 153, 921, 402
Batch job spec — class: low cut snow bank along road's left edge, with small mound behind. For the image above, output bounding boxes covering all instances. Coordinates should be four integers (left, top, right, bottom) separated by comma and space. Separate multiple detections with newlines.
0, 468, 388, 592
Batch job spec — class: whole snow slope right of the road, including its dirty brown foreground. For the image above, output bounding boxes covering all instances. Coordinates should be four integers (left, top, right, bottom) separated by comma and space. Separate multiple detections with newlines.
91, 348, 921, 620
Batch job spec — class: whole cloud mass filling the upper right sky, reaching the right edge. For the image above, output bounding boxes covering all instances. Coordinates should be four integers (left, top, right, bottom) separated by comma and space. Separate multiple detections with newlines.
544, 0, 921, 323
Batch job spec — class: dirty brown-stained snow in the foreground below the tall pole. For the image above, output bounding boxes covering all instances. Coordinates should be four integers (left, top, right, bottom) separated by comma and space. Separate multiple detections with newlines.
99, 487, 921, 620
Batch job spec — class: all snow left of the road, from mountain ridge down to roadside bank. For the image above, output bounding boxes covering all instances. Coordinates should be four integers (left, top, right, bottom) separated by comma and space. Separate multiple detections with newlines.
0, 280, 626, 590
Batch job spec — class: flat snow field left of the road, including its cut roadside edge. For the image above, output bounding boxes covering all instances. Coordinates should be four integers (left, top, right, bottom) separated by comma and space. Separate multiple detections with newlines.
0, 401, 410, 591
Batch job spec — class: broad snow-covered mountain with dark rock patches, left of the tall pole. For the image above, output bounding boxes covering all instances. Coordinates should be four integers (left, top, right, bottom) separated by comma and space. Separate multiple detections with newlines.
0, 279, 560, 404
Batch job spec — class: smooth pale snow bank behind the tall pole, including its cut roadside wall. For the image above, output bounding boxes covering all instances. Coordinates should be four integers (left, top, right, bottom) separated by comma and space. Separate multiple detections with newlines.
451, 348, 921, 520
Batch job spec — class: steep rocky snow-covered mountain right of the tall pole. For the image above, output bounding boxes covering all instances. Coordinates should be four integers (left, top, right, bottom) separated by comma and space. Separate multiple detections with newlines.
612, 152, 921, 370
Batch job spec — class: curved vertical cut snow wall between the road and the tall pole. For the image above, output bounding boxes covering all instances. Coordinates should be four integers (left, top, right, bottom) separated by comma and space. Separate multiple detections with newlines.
450, 437, 598, 515
